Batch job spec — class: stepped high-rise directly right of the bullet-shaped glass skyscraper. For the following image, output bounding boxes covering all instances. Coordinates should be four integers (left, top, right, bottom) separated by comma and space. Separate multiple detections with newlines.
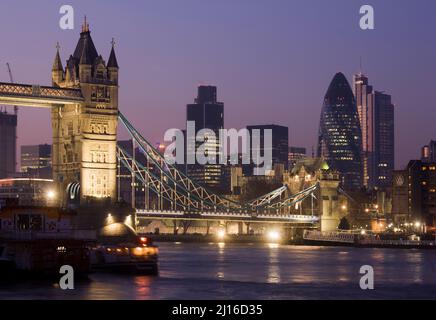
354, 73, 395, 189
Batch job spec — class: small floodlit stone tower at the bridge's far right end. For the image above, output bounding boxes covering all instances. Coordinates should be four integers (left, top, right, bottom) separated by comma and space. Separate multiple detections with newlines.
319, 170, 342, 232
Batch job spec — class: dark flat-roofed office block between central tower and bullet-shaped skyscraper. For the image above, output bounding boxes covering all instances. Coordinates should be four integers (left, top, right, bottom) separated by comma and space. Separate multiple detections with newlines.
244, 124, 289, 175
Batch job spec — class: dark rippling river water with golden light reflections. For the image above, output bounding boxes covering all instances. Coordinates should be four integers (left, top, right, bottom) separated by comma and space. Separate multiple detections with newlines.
0, 243, 436, 300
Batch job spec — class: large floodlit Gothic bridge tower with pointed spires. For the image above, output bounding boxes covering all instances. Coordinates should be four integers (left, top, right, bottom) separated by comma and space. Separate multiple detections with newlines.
51, 18, 119, 204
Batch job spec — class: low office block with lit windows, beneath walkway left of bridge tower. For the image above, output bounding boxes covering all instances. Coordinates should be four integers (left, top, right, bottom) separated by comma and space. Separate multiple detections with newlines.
21, 144, 53, 179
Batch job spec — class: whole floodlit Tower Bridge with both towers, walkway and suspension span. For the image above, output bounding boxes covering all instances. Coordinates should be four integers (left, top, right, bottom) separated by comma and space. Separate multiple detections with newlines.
0, 22, 346, 229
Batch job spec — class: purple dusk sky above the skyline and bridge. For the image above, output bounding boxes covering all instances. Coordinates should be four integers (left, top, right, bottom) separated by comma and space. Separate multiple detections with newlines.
0, 0, 436, 167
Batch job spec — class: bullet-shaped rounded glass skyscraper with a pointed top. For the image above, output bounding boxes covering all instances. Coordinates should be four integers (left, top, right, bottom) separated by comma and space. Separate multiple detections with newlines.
318, 73, 362, 190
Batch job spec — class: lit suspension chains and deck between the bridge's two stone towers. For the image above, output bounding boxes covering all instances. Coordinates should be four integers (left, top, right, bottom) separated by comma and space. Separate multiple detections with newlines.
117, 113, 319, 224
